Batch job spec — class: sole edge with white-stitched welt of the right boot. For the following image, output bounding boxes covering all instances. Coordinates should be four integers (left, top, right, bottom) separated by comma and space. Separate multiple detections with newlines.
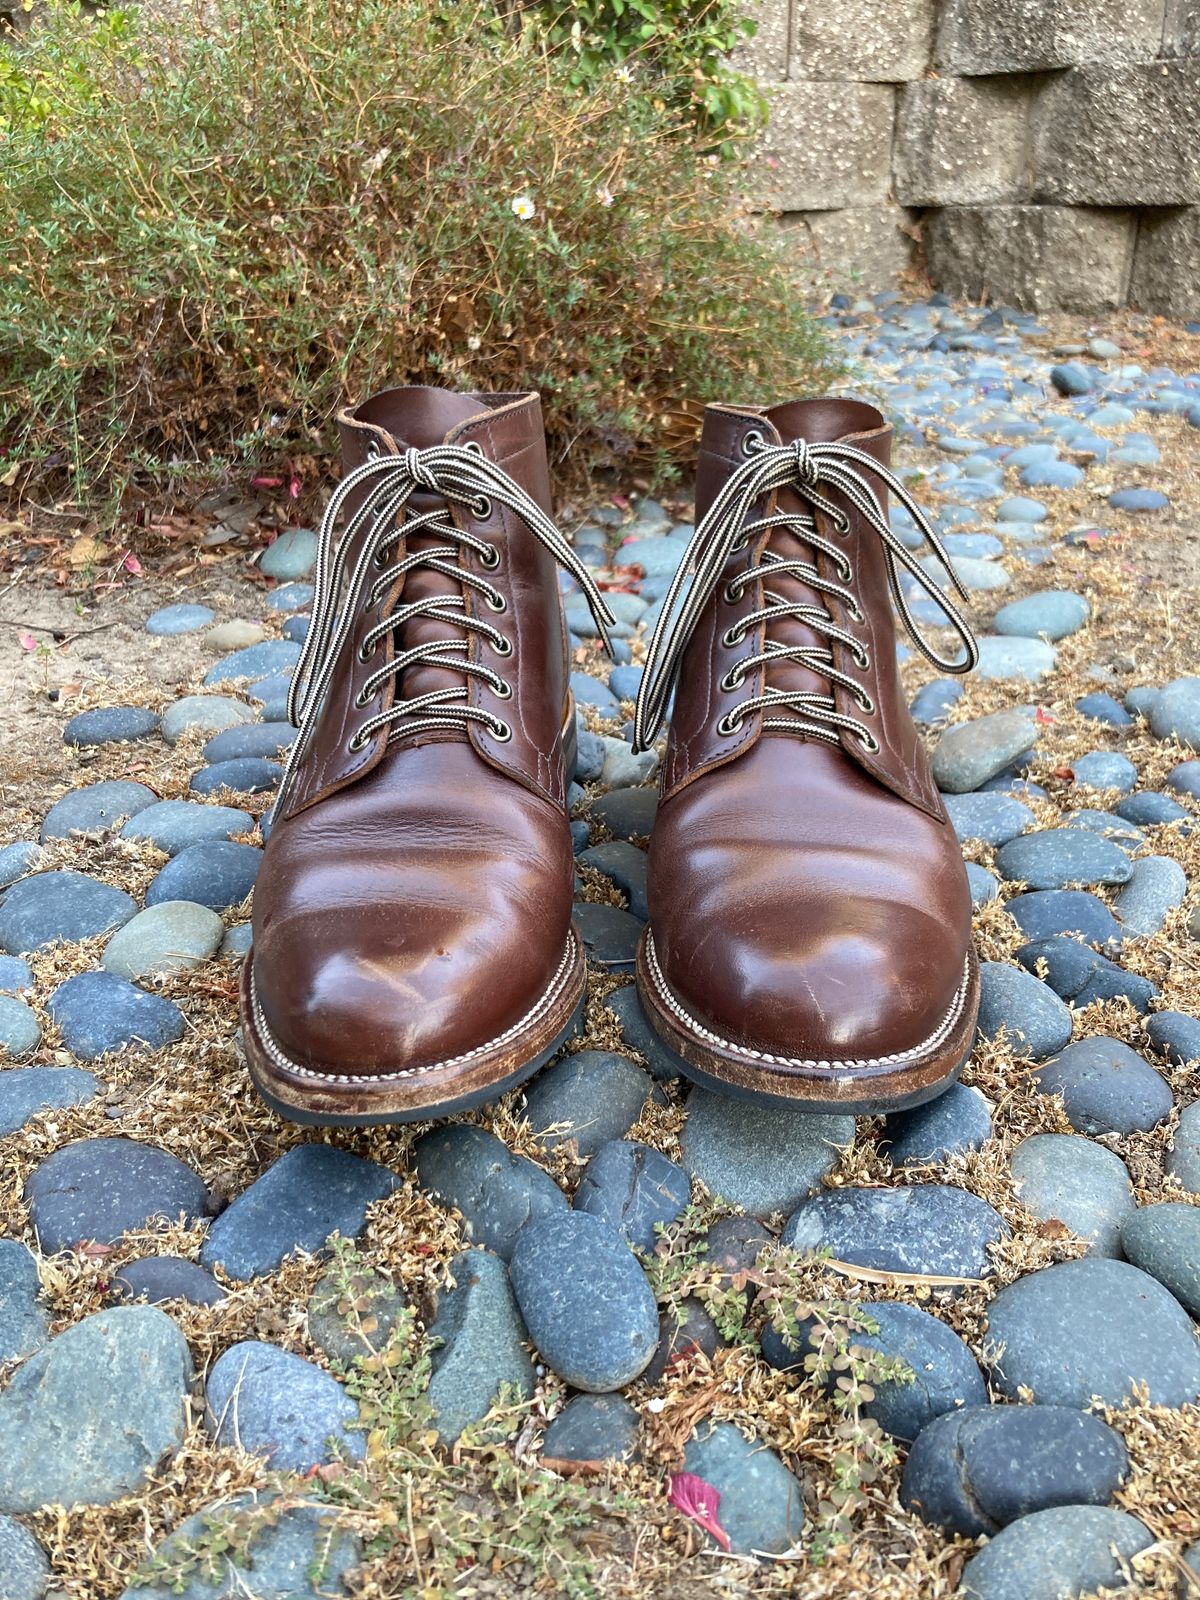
637, 928, 979, 1117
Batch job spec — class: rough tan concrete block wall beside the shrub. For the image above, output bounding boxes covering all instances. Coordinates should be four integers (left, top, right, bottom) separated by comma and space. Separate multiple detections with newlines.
738, 0, 1200, 320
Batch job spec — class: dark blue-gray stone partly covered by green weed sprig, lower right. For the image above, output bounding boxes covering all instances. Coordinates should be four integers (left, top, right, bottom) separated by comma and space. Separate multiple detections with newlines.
762, 1301, 987, 1440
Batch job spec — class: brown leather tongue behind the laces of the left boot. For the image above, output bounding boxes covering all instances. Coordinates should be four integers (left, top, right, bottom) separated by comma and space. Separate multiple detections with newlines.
357, 389, 502, 738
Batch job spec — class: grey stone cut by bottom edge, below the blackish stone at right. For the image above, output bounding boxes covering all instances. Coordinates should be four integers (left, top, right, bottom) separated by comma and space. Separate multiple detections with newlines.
962, 1506, 1154, 1600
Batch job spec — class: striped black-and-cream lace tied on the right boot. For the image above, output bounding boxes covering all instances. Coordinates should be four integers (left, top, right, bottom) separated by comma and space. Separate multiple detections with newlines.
634, 432, 979, 752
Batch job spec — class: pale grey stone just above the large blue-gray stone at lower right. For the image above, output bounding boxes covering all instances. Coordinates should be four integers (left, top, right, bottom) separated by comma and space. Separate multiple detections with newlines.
1010, 1133, 1134, 1256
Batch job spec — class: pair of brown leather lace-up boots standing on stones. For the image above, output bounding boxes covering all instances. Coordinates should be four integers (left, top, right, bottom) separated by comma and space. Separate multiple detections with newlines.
243, 389, 979, 1125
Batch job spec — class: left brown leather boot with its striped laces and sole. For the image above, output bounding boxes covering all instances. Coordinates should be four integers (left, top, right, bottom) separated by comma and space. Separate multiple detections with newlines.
242, 389, 611, 1123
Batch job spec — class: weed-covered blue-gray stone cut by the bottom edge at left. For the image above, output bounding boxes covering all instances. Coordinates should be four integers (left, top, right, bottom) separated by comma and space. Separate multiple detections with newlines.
122, 1490, 362, 1600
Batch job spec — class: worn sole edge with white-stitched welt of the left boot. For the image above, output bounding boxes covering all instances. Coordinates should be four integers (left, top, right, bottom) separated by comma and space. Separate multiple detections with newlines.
242, 928, 587, 1128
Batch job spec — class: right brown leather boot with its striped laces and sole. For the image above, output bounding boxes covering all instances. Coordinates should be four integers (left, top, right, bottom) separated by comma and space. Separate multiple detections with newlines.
637, 400, 979, 1112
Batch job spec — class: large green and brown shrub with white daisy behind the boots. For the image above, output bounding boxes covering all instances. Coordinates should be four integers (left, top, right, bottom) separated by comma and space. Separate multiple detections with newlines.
0, 0, 830, 504
